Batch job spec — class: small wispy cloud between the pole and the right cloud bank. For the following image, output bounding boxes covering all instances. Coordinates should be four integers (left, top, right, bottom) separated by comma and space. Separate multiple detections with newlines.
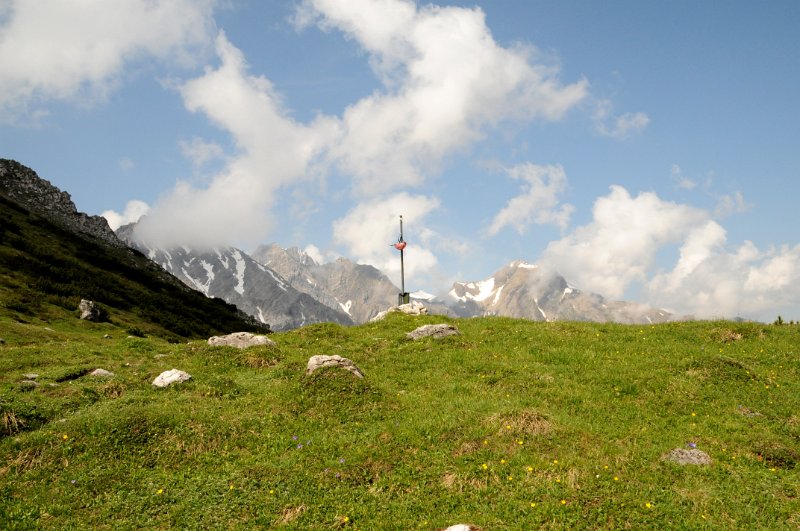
488, 163, 574, 236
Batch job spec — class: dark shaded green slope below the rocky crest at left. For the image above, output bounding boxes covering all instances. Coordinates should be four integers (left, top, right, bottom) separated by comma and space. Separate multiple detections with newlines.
0, 196, 268, 340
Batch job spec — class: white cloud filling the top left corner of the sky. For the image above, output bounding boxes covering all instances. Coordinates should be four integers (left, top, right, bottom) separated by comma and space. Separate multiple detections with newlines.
0, 0, 216, 120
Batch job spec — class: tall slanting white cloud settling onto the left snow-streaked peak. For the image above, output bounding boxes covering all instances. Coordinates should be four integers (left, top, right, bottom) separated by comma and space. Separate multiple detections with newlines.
136, 33, 336, 248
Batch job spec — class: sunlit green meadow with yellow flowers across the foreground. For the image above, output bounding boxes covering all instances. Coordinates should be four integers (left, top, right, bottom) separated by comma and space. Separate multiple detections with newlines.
0, 316, 800, 530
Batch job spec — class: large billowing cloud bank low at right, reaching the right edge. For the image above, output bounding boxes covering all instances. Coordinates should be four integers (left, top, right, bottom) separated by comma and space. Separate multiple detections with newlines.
541, 186, 800, 320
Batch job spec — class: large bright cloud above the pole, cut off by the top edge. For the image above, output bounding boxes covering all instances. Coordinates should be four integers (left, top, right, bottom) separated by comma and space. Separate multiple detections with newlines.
298, 0, 588, 194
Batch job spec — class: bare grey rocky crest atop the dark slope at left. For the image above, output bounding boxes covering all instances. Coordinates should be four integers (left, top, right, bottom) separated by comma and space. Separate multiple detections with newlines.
0, 159, 127, 248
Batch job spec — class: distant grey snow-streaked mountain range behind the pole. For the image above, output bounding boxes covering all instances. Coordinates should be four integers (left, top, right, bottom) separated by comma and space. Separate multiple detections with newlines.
117, 221, 674, 330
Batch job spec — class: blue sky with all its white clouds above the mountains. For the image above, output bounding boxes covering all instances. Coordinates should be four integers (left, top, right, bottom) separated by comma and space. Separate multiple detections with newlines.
0, 0, 800, 321
